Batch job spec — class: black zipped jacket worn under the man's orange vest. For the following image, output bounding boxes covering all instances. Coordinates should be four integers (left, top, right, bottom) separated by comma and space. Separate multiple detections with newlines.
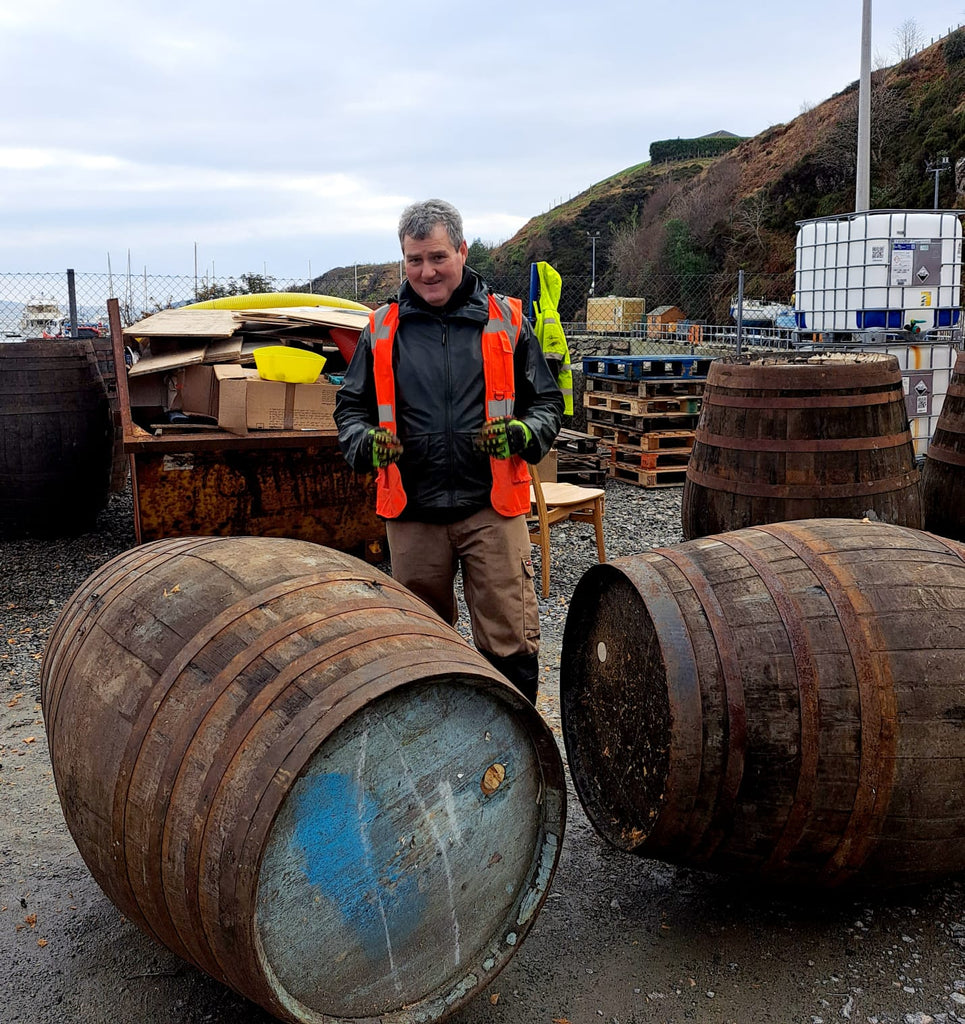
335, 267, 563, 521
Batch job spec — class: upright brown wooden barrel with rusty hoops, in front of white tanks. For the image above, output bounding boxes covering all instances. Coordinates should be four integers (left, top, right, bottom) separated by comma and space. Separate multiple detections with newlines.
682, 352, 922, 540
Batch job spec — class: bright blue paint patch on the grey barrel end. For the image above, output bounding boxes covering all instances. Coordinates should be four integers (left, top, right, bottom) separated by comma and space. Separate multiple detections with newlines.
292, 773, 425, 963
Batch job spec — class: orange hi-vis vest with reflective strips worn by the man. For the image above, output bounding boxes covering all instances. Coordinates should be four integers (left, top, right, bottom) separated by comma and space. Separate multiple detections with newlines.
369, 294, 530, 519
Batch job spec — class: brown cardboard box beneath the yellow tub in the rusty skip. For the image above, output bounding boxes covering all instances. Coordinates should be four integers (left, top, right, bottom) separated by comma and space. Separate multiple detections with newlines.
213, 366, 338, 434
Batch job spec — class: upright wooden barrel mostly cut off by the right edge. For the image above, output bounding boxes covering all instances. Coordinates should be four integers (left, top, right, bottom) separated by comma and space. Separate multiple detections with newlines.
921, 352, 965, 541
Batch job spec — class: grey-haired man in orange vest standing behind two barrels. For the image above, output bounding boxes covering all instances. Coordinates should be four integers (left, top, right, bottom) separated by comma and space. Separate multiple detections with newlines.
335, 200, 563, 703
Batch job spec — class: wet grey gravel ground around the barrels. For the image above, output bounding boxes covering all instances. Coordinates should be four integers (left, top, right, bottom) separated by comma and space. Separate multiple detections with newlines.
0, 481, 965, 1024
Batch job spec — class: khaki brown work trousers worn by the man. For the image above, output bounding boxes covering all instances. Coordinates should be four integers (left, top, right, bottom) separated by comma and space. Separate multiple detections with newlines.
385, 508, 540, 657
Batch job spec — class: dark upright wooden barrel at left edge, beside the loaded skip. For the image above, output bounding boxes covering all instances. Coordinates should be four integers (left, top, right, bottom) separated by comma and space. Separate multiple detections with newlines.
0, 339, 114, 536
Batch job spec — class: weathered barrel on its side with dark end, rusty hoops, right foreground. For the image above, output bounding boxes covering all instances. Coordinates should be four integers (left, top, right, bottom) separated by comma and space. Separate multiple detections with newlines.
560, 519, 965, 887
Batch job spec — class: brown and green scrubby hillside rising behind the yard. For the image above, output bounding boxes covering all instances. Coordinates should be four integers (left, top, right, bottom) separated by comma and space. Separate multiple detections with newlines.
317, 30, 965, 319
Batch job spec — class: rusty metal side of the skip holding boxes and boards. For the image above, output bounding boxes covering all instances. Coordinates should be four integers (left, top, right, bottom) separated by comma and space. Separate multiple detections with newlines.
133, 437, 385, 551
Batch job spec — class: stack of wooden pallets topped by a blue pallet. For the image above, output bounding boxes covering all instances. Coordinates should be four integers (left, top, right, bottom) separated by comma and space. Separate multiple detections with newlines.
583, 355, 712, 487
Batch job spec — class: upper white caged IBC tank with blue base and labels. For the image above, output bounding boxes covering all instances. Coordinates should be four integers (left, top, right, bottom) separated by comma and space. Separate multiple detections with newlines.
794, 210, 962, 340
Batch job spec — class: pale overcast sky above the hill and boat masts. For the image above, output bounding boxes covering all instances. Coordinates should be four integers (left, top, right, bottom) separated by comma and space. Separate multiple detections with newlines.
0, 0, 965, 279
